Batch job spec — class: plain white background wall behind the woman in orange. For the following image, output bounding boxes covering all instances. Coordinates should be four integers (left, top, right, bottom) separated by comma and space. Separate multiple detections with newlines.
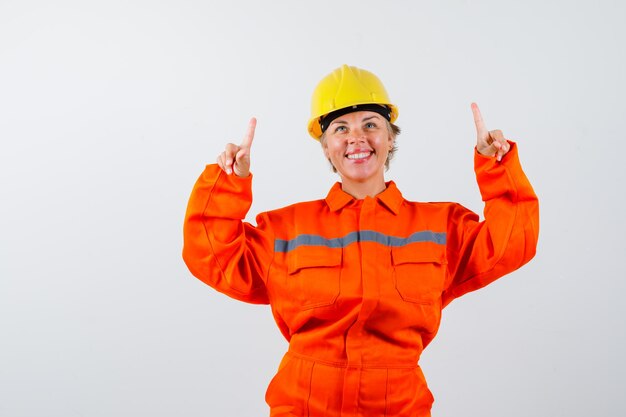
0, 0, 626, 417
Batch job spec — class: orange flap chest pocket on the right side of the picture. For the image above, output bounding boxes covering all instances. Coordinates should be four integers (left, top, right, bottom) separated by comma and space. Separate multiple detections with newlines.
391, 243, 448, 304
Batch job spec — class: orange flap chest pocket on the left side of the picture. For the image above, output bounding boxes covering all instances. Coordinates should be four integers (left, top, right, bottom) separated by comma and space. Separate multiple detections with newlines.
287, 246, 343, 310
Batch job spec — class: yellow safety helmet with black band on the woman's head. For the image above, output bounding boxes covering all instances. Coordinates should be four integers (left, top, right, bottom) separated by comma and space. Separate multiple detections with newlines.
308, 65, 398, 140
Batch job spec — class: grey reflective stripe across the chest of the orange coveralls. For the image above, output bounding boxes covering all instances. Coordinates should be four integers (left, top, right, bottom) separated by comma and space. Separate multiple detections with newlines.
274, 230, 446, 252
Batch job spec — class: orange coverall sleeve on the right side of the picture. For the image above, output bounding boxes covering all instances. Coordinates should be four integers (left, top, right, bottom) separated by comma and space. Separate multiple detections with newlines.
442, 142, 539, 306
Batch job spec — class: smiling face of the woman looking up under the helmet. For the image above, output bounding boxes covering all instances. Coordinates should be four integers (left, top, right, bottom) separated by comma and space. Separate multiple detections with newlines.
323, 111, 393, 187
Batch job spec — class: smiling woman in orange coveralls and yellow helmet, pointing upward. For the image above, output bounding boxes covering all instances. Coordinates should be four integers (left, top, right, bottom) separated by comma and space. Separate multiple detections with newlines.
183, 65, 538, 417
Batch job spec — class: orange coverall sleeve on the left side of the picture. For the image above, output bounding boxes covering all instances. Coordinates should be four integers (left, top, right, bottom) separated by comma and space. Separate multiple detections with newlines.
178, 164, 274, 304
